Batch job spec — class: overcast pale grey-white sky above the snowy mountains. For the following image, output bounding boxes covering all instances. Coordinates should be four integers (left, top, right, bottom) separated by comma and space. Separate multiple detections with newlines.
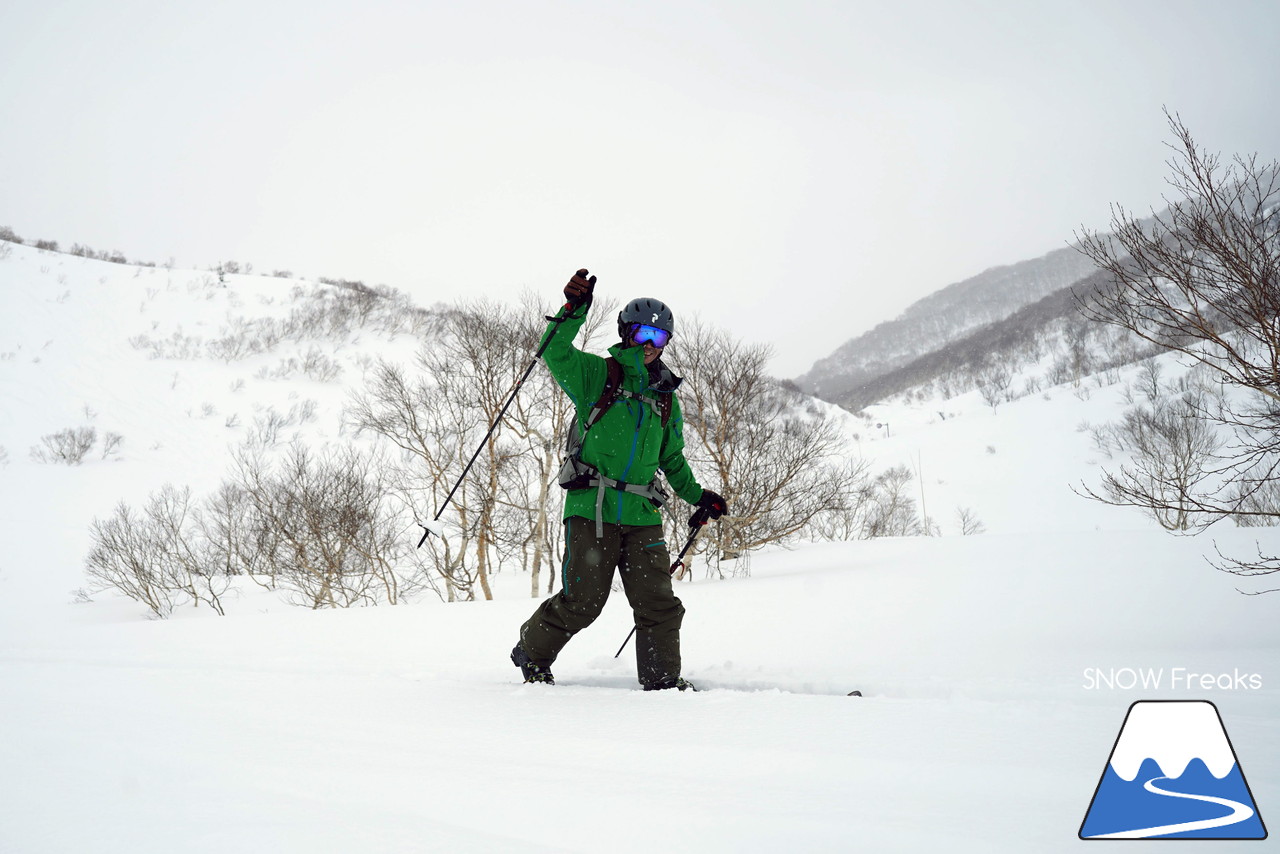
0, 0, 1280, 376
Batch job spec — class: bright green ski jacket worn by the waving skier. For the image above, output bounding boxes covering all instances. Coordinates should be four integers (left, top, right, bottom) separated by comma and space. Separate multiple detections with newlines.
543, 300, 703, 525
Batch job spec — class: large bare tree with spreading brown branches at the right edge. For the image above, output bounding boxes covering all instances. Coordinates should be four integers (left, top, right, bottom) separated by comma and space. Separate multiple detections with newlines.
1078, 113, 1280, 591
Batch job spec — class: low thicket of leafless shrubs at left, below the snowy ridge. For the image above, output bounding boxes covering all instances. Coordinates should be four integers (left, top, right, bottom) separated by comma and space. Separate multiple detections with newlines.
86, 444, 430, 617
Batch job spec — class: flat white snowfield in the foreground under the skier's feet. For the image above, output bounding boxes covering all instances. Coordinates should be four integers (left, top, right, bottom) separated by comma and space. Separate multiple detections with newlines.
0, 517, 1280, 851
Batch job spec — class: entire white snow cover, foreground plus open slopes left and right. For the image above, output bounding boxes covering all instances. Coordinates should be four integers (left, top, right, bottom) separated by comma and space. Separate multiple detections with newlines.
0, 241, 1280, 854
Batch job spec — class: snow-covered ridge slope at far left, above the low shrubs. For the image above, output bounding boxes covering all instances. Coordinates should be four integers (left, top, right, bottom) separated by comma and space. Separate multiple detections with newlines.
0, 243, 425, 483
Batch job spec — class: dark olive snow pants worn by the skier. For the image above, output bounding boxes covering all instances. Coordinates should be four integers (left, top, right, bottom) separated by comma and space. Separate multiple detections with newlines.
520, 516, 685, 685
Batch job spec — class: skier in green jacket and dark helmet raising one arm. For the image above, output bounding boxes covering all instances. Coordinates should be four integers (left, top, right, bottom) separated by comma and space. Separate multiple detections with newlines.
511, 270, 726, 691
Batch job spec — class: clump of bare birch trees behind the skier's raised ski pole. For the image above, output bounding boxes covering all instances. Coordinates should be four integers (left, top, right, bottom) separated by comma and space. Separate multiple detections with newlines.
347, 297, 613, 600
